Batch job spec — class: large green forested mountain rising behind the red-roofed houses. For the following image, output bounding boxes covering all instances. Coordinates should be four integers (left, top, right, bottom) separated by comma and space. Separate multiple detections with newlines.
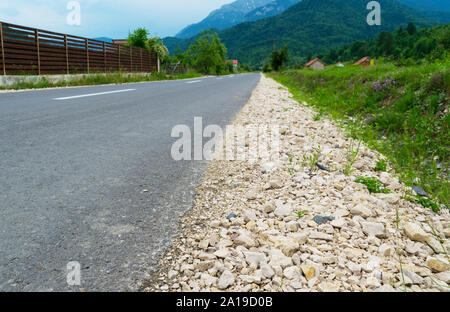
219, 0, 438, 65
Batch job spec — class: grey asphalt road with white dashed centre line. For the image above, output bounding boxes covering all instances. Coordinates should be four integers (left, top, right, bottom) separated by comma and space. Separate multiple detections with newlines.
0, 74, 260, 291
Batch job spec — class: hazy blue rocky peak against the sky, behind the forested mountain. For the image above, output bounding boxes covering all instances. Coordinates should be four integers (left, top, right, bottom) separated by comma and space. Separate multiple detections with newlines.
175, 0, 300, 39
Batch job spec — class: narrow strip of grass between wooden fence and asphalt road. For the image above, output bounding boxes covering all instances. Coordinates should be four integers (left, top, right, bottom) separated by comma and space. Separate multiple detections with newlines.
0, 72, 202, 90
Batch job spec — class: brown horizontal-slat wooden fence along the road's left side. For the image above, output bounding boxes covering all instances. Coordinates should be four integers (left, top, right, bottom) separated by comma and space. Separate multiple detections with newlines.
0, 22, 158, 75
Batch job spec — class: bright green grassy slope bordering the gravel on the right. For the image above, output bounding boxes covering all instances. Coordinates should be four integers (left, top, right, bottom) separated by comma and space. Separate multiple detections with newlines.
269, 59, 450, 210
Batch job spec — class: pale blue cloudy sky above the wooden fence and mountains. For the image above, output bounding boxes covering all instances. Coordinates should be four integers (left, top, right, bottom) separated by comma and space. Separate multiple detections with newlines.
0, 0, 234, 39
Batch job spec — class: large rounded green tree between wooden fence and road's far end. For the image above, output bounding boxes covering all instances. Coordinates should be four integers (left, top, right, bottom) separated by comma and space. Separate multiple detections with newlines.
186, 31, 227, 74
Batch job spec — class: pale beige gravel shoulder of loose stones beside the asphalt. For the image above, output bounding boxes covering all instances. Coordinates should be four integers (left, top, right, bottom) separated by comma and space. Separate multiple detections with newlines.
143, 77, 450, 292
